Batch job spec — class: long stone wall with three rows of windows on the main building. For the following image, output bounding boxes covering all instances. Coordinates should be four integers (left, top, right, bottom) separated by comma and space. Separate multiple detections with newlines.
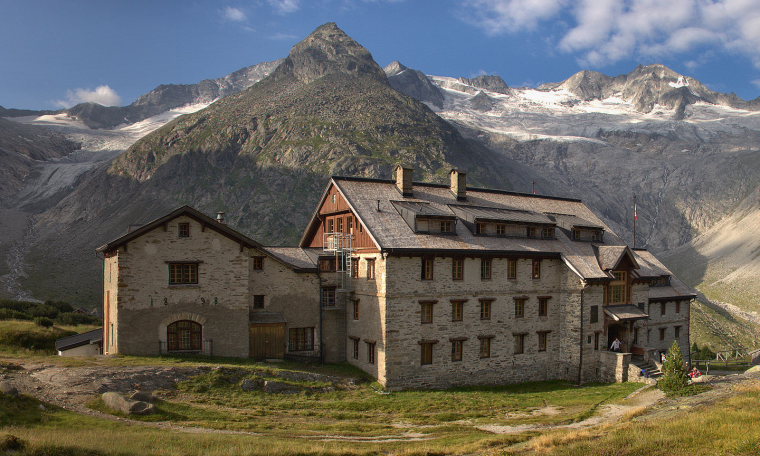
384, 257, 579, 389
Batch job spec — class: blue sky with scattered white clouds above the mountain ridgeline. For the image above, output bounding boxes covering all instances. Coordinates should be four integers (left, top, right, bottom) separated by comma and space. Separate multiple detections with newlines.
0, 0, 760, 109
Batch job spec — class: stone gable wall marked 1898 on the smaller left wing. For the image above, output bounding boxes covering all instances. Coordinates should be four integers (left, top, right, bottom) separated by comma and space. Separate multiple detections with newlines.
114, 216, 251, 357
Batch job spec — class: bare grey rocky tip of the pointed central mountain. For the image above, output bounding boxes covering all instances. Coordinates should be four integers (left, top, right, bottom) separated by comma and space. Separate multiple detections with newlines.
273, 22, 387, 83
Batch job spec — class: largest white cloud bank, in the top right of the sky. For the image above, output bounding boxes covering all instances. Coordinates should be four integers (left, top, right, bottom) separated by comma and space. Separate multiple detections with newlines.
464, 0, 760, 67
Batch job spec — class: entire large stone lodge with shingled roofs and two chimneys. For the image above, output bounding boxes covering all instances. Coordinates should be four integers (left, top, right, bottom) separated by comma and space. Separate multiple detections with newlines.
98, 167, 694, 388
